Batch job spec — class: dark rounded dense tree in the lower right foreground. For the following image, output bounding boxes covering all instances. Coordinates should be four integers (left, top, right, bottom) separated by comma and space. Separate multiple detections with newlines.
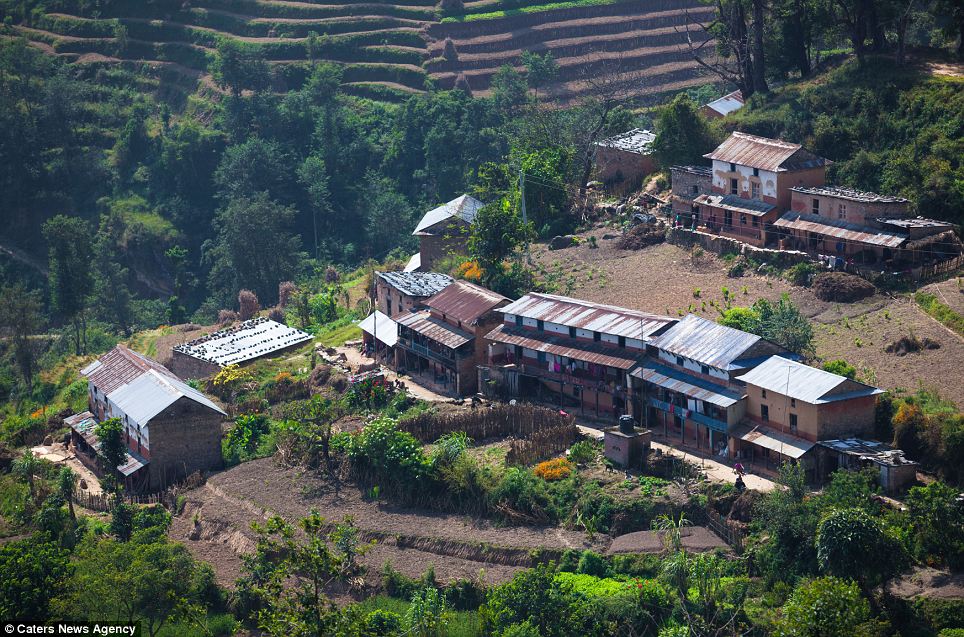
816, 509, 902, 588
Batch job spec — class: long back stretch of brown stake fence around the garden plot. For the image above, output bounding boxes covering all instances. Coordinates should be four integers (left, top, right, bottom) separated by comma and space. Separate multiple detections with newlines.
399, 404, 575, 442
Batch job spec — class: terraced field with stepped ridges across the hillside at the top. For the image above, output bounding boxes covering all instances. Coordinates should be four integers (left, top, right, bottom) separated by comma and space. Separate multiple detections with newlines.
7, 0, 711, 100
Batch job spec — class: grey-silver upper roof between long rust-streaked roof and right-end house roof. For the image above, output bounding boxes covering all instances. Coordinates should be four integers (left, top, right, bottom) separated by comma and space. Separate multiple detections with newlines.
650, 314, 762, 370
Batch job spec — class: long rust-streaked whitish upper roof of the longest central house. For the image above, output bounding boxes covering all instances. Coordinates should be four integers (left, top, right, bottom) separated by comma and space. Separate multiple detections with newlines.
499, 292, 676, 340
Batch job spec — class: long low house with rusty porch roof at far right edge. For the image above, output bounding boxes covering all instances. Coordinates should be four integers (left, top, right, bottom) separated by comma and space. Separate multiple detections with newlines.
774, 186, 961, 264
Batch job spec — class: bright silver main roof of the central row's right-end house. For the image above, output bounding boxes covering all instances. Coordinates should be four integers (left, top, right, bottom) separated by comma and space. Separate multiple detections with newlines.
738, 356, 883, 405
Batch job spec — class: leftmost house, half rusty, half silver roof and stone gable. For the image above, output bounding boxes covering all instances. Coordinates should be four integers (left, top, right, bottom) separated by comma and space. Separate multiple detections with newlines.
73, 345, 227, 491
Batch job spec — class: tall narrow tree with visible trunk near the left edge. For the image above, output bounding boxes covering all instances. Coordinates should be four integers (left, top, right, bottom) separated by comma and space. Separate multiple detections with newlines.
43, 215, 94, 356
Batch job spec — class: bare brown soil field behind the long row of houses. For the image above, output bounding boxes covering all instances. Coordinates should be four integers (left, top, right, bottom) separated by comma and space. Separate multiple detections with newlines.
532, 228, 964, 407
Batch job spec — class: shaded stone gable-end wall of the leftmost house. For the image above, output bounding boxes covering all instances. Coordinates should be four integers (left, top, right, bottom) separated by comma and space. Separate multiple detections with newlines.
148, 398, 224, 491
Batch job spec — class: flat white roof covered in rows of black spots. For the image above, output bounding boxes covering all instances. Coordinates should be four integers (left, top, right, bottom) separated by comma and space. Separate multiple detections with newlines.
174, 318, 313, 367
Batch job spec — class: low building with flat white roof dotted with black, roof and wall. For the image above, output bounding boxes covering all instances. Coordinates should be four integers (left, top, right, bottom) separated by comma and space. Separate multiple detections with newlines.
171, 318, 313, 378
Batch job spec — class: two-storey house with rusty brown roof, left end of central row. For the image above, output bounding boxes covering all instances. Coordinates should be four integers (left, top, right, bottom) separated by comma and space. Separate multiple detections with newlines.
395, 281, 510, 395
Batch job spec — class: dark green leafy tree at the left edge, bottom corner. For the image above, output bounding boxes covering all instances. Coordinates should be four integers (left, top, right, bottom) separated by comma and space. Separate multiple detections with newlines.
0, 536, 70, 622
